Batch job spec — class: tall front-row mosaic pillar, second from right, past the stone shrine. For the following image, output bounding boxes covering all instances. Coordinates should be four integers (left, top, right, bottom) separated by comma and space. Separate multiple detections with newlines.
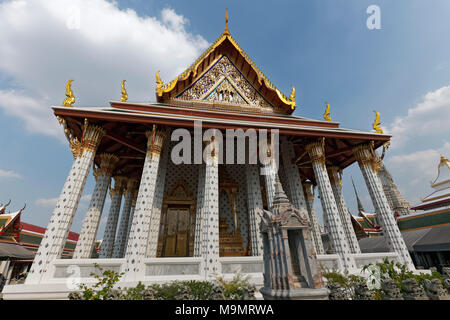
306, 139, 356, 270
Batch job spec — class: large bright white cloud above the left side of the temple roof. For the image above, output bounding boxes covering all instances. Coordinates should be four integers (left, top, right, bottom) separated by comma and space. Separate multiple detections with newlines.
0, 0, 207, 137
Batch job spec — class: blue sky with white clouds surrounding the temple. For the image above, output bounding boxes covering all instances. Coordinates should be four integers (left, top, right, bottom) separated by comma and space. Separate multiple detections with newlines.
0, 0, 450, 238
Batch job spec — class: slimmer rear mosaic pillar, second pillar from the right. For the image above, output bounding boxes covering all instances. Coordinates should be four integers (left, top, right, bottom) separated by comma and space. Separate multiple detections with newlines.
328, 166, 361, 253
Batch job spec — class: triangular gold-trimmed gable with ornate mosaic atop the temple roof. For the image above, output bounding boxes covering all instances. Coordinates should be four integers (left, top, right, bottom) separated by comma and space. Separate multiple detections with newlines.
156, 11, 296, 114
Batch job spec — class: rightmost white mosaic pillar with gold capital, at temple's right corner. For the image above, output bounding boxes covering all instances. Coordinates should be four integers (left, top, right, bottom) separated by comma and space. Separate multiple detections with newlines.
353, 143, 415, 270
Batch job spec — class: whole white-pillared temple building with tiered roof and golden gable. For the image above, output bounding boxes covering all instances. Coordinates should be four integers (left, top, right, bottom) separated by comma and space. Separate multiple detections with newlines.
0, 14, 414, 299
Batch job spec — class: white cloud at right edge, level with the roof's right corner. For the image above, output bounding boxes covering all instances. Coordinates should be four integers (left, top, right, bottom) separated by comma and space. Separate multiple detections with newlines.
386, 86, 450, 149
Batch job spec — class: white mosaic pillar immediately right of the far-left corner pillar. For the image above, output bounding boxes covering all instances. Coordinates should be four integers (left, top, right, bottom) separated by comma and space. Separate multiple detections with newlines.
73, 153, 119, 259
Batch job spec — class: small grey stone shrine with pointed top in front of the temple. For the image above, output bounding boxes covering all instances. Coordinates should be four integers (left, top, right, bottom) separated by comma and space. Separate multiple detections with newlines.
258, 177, 328, 300
